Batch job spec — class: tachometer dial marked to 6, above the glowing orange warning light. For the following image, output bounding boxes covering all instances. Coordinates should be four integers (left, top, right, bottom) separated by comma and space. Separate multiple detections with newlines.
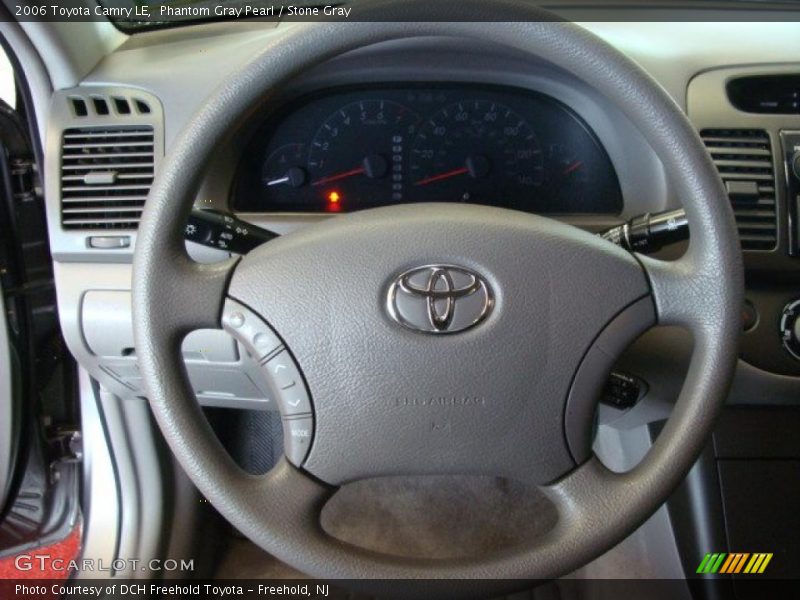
307, 99, 419, 208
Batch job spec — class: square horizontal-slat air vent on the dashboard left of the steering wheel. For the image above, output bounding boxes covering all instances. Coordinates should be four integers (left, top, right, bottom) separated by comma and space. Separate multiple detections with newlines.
61, 126, 154, 229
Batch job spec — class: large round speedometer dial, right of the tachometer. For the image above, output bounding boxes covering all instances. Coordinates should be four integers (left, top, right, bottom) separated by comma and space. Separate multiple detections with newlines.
409, 99, 544, 206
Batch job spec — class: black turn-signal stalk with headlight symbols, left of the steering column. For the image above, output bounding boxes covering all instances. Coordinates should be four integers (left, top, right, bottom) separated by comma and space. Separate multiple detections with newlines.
183, 209, 278, 254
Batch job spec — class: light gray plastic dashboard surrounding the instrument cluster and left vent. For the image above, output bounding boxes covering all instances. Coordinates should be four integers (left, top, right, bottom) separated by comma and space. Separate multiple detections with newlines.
36, 22, 800, 419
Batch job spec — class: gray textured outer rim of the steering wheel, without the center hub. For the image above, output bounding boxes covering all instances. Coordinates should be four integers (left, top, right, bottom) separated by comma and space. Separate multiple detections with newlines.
133, 2, 743, 592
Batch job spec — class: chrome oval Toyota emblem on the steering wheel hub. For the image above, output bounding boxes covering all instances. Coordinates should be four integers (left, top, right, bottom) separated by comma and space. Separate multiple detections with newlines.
388, 265, 494, 333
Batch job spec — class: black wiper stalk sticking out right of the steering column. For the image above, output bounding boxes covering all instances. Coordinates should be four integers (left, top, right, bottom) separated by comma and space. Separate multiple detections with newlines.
598, 208, 689, 253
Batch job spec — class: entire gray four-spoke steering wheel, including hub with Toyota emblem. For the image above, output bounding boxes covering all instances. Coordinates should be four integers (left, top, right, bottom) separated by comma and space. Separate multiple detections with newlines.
133, 0, 743, 592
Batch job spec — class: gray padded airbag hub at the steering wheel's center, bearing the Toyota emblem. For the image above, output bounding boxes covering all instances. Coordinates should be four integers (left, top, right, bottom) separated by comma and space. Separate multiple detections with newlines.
223, 204, 648, 483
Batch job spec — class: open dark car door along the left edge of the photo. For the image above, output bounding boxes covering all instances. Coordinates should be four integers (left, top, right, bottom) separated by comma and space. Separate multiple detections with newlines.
0, 40, 81, 578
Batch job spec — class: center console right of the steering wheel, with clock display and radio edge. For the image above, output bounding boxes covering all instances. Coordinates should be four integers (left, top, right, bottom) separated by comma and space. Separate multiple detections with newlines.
668, 67, 800, 600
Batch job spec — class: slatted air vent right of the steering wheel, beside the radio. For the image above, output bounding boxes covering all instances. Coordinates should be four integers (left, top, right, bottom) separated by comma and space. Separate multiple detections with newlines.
700, 129, 778, 250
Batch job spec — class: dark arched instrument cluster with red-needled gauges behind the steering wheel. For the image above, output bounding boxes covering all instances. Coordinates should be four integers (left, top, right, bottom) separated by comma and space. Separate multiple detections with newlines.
233, 84, 623, 215
